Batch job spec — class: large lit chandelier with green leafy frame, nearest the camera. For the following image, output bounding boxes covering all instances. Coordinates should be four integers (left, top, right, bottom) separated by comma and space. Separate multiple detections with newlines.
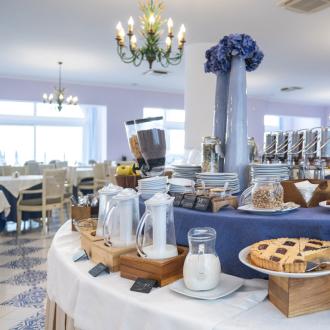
116, 0, 186, 70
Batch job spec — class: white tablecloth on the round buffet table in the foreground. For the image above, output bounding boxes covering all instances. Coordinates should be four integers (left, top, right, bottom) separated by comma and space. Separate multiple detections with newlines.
47, 222, 330, 330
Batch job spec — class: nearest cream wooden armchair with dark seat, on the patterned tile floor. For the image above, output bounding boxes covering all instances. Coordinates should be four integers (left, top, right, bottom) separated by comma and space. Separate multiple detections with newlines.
17, 169, 66, 234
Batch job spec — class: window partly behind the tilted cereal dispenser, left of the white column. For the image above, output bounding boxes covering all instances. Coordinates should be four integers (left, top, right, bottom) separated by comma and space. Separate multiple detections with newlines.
143, 108, 185, 163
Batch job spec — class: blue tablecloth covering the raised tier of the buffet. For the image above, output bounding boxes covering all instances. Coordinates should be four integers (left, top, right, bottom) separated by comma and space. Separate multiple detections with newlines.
140, 202, 330, 278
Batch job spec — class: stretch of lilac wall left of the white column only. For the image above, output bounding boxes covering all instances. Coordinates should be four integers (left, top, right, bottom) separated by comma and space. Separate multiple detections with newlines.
0, 78, 183, 160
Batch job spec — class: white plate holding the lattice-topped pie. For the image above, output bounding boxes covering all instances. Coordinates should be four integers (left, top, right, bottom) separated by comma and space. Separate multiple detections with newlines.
238, 246, 330, 278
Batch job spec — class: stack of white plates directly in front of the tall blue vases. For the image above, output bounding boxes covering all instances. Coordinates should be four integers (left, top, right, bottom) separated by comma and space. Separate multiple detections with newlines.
197, 172, 240, 194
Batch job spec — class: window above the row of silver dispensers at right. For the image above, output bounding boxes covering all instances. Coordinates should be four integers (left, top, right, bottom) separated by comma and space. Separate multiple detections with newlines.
264, 115, 321, 132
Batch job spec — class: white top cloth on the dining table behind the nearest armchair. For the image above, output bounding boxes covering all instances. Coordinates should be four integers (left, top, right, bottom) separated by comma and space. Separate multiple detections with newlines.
0, 175, 42, 198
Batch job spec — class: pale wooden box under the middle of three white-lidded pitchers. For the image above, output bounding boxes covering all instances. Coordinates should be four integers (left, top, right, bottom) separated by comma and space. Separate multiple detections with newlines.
91, 240, 136, 272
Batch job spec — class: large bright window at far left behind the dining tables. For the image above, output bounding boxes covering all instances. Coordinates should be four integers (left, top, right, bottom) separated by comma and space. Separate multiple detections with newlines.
0, 101, 106, 165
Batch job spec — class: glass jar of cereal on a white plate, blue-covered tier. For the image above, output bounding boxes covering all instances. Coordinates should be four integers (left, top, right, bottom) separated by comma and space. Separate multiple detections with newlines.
252, 177, 284, 209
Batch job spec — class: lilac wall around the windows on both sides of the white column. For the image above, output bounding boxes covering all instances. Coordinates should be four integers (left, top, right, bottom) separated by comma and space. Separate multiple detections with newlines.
0, 78, 330, 160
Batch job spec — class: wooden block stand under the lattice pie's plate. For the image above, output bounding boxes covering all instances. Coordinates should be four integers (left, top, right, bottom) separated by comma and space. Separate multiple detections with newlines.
268, 275, 330, 317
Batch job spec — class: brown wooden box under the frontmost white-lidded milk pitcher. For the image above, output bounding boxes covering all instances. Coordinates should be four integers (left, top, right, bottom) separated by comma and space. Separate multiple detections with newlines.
120, 246, 188, 286
